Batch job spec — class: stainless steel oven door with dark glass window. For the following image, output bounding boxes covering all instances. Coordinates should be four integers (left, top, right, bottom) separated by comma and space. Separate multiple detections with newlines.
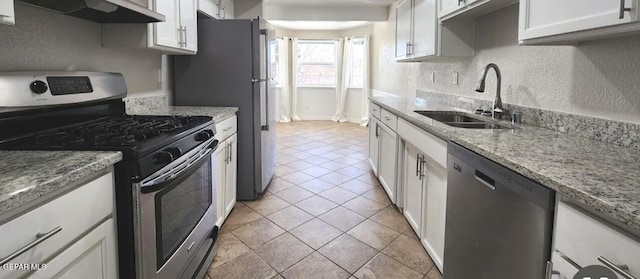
133, 139, 218, 279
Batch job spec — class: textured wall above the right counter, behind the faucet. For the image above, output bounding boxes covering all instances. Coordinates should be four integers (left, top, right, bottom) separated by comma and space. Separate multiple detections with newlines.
372, 5, 640, 123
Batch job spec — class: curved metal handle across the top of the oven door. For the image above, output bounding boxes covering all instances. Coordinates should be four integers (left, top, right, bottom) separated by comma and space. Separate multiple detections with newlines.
140, 139, 219, 194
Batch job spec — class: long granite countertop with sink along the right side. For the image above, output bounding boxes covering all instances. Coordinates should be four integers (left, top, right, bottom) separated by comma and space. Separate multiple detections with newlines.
370, 96, 640, 231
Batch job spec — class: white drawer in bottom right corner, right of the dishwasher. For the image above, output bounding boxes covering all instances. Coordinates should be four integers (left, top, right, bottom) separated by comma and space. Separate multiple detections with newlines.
554, 202, 640, 277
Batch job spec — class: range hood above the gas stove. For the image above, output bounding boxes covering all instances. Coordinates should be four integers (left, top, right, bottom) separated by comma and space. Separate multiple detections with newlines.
18, 0, 165, 23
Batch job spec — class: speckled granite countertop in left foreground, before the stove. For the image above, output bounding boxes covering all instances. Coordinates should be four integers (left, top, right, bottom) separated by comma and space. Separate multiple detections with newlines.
0, 151, 122, 219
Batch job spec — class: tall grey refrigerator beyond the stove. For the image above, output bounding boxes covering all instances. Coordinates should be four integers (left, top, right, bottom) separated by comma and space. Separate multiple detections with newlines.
173, 19, 276, 200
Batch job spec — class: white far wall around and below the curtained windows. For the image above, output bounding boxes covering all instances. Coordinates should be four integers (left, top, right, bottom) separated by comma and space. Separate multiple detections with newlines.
276, 25, 373, 123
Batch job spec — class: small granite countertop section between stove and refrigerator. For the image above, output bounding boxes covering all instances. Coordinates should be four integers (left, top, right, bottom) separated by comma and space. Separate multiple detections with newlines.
127, 106, 238, 123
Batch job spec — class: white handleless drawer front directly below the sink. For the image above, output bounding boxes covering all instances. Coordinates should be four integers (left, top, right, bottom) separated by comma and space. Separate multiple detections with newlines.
397, 119, 447, 169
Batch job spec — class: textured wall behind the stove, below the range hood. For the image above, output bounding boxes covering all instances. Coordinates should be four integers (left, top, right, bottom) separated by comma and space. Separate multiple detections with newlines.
0, 3, 170, 96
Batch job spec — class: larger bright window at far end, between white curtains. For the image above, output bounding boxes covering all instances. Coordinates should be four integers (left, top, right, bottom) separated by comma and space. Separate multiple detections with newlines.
296, 40, 336, 86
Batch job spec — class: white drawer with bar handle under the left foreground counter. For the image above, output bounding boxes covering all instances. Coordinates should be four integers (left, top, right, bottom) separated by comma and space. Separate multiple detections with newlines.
0, 172, 114, 278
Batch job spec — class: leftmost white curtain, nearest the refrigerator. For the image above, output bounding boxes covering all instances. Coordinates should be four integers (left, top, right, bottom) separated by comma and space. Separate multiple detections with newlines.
278, 37, 291, 122
